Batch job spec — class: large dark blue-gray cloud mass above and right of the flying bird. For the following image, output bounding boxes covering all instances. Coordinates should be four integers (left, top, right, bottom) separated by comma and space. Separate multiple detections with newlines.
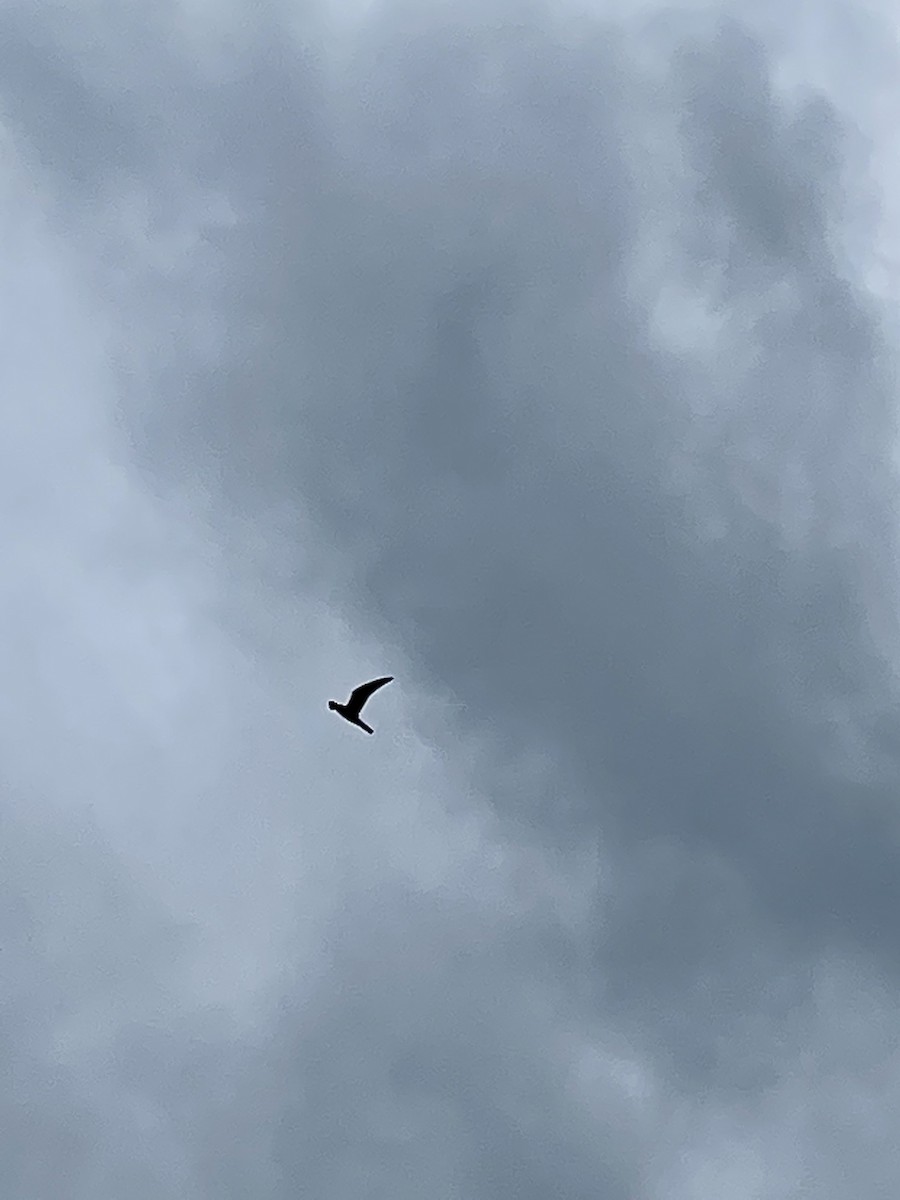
151, 4, 898, 959
